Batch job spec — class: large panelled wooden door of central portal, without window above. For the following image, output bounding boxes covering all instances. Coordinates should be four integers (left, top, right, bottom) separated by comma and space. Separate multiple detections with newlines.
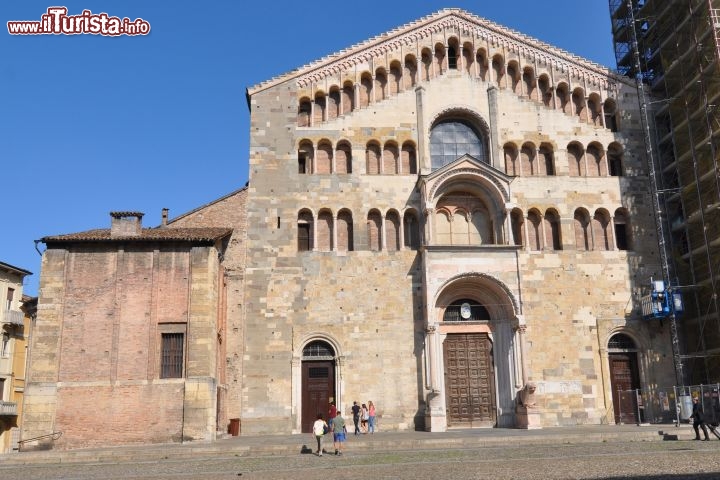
443, 333, 497, 427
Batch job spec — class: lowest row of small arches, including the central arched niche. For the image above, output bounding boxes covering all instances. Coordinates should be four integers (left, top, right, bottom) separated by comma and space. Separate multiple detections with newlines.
297, 207, 630, 252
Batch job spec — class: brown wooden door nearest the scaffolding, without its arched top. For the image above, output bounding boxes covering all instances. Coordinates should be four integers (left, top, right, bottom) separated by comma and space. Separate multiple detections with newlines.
608, 352, 640, 423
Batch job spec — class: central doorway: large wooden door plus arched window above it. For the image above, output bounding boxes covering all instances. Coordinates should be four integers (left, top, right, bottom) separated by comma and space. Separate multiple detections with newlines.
443, 298, 497, 427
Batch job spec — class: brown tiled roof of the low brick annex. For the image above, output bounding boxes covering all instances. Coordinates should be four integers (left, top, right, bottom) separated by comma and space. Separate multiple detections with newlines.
42, 227, 232, 243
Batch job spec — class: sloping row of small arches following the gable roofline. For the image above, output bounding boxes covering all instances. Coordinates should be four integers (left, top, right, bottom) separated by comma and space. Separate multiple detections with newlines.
297, 39, 617, 131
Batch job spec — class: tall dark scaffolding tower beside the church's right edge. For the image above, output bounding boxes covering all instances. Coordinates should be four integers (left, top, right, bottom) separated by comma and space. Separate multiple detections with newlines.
609, 0, 720, 384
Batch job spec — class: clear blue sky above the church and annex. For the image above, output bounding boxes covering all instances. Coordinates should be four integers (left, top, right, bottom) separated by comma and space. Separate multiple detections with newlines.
0, 0, 615, 295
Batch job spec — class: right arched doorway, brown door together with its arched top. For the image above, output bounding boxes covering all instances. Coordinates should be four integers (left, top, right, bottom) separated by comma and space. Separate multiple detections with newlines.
608, 333, 644, 424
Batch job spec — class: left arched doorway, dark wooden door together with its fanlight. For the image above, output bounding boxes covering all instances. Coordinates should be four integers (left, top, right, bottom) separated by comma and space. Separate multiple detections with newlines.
301, 340, 337, 433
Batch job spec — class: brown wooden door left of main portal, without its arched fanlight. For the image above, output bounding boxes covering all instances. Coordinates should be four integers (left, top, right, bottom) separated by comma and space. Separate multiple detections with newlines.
302, 361, 335, 433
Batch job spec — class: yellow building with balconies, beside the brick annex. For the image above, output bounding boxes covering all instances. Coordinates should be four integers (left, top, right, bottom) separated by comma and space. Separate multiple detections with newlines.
0, 262, 32, 453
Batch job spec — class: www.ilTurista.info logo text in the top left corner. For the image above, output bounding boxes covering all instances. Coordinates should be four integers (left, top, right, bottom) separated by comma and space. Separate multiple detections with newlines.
8, 7, 150, 36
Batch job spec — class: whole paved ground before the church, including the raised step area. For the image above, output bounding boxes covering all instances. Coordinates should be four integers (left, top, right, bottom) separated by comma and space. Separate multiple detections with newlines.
0, 425, 720, 480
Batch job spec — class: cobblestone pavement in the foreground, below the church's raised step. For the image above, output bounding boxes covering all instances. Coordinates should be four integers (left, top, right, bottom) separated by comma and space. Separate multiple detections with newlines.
0, 440, 720, 480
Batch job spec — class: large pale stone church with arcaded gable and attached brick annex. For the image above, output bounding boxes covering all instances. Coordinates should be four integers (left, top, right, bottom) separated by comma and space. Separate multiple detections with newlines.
23, 9, 673, 448
